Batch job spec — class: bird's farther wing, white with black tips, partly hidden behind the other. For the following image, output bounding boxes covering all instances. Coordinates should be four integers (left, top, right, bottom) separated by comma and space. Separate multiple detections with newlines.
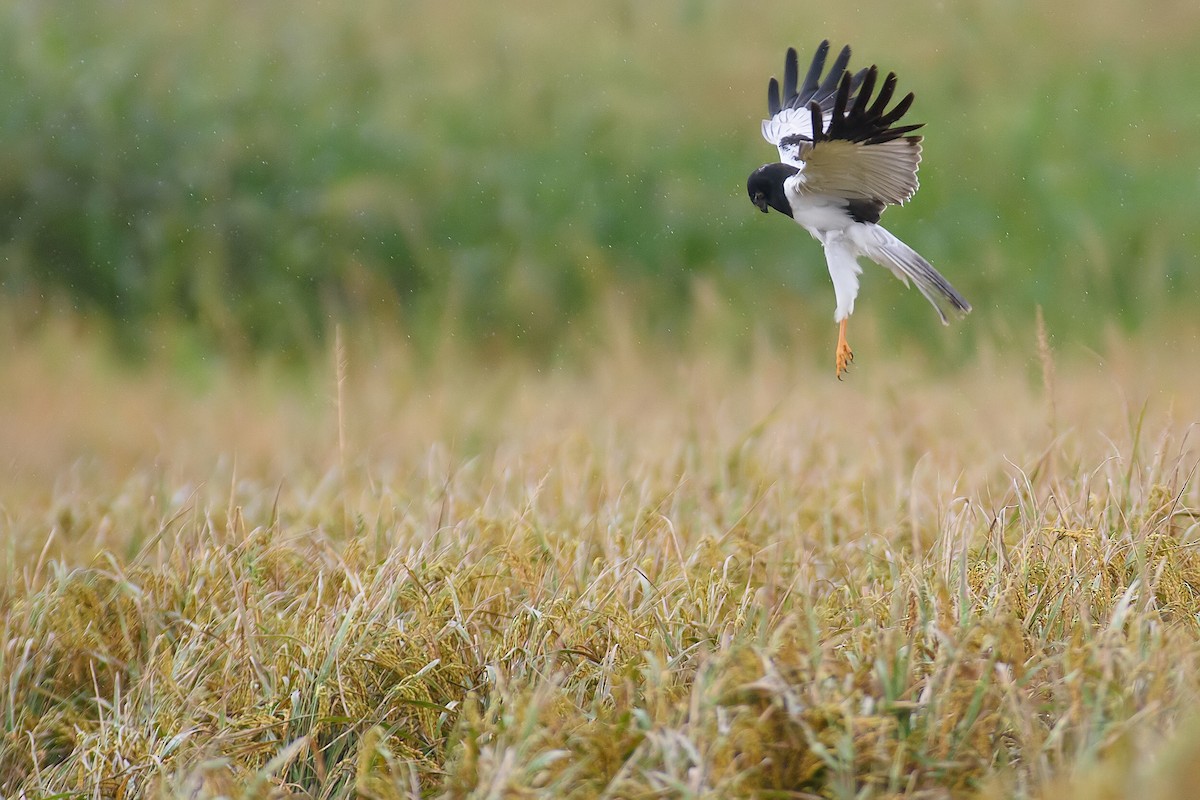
762, 40, 866, 167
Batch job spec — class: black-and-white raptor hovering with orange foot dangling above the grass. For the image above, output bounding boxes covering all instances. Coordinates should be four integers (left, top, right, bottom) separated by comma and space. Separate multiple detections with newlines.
746, 40, 971, 380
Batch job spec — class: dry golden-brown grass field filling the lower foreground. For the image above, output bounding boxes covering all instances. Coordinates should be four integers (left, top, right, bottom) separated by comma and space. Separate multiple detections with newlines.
0, 323, 1200, 799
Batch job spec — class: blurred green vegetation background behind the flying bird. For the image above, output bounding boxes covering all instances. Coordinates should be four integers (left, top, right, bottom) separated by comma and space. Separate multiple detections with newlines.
0, 0, 1200, 354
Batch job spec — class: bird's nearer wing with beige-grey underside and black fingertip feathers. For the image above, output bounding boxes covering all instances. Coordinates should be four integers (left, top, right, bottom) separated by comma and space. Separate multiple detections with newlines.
797, 67, 922, 210
